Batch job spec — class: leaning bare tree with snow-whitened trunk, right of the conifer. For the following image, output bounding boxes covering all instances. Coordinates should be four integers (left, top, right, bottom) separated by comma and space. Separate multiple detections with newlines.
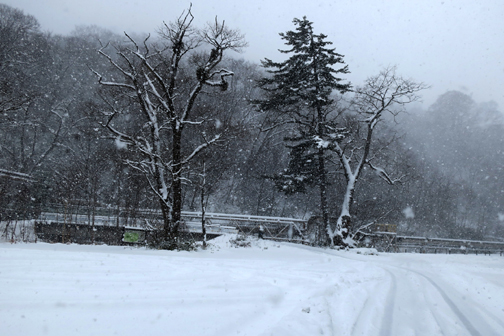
319, 67, 426, 245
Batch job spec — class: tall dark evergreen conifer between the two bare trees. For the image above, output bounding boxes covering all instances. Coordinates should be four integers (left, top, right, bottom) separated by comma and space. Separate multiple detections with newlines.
256, 17, 351, 240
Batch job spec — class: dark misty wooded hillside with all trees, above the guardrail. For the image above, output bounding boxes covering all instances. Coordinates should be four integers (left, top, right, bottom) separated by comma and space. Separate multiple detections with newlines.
0, 5, 504, 244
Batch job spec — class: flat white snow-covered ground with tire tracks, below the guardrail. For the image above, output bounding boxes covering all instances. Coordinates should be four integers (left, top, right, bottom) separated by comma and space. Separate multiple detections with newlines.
0, 236, 504, 336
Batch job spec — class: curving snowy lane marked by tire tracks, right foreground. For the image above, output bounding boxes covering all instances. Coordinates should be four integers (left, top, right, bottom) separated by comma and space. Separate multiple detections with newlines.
296, 245, 504, 336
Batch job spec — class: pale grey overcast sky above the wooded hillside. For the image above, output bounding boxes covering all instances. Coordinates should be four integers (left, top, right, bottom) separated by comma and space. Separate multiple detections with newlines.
4, 0, 504, 111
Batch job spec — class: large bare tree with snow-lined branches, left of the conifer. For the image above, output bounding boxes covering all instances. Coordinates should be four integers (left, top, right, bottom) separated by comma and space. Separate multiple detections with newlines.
95, 8, 246, 240
